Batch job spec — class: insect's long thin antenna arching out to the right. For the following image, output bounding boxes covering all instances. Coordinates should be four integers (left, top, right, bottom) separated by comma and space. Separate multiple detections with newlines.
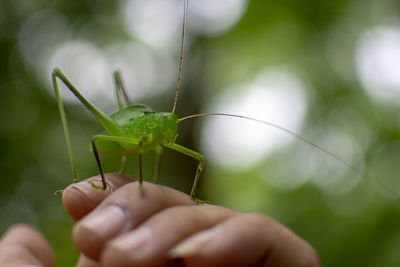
179, 113, 399, 197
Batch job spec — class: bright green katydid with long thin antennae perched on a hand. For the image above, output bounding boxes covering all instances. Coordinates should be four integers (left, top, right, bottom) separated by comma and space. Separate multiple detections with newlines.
52, 0, 396, 202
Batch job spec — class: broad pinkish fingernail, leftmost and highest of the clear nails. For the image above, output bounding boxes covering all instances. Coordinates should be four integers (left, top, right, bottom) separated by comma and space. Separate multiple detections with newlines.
79, 205, 127, 236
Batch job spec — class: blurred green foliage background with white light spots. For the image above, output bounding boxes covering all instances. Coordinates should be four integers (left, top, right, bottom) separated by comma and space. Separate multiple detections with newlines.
0, 0, 400, 266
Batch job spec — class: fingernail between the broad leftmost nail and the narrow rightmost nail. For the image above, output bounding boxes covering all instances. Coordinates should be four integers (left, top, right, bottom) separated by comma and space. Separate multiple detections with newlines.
111, 226, 153, 258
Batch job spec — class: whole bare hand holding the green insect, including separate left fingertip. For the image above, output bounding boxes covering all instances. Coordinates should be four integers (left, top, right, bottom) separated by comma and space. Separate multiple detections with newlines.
0, 174, 319, 267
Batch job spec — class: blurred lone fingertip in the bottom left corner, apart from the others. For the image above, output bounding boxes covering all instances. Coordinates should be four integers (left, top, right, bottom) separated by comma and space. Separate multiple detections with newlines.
0, 224, 54, 267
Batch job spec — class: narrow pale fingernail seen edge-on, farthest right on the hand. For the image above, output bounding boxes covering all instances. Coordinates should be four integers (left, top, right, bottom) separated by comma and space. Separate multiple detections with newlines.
168, 227, 221, 258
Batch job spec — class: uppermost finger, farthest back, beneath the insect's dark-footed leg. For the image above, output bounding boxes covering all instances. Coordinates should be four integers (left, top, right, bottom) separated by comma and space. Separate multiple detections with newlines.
62, 173, 134, 221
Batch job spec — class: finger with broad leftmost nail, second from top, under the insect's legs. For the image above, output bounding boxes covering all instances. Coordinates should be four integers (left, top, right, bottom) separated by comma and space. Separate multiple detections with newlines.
73, 182, 194, 260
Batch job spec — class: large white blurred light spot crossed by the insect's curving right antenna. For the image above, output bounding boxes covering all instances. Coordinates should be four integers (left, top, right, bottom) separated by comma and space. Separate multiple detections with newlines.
201, 69, 306, 169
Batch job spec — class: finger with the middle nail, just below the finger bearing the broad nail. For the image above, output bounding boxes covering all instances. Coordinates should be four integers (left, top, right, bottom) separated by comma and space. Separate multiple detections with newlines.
101, 204, 235, 266
